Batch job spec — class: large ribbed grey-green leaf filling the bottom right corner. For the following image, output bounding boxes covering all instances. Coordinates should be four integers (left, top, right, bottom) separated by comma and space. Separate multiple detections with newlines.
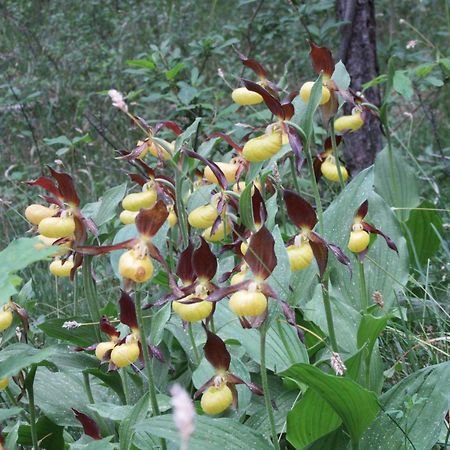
361, 362, 450, 450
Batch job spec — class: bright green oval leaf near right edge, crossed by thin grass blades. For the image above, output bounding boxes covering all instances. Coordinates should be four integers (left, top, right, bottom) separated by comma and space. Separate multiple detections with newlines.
405, 201, 444, 265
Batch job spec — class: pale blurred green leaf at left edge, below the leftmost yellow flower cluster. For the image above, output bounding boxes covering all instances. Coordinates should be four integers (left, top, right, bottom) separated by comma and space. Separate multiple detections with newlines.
0, 237, 57, 306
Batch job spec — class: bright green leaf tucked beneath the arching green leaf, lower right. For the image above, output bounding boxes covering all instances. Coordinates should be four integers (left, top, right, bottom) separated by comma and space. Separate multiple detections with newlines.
286, 388, 342, 449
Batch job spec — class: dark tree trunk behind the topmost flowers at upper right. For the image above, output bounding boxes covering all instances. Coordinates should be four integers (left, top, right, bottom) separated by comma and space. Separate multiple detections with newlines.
336, 0, 382, 173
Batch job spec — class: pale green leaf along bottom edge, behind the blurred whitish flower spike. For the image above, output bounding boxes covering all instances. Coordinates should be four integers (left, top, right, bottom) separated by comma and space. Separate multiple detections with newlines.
135, 415, 273, 450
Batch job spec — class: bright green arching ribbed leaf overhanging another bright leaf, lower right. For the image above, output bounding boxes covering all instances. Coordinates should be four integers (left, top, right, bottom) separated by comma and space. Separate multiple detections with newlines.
281, 364, 379, 442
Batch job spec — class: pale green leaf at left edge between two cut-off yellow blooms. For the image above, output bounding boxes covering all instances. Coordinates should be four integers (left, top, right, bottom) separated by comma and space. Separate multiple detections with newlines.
0, 344, 58, 378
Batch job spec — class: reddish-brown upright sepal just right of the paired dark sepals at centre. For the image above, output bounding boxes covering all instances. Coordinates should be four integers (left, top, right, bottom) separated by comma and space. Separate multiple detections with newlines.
244, 225, 277, 280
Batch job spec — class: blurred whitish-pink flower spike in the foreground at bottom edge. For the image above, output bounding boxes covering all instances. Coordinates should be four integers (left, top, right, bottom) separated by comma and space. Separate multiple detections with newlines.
170, 384, 195, 450
